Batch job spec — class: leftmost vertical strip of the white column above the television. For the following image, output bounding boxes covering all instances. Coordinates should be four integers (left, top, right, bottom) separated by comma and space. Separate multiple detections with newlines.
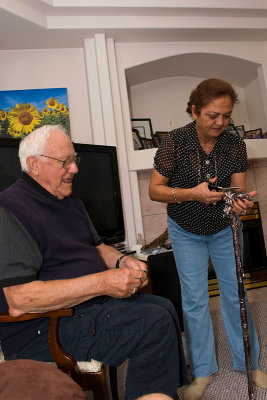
84, 39, 106, 145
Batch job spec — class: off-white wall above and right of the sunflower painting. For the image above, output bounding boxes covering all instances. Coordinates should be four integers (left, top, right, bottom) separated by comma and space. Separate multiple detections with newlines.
0, 49, 92, 143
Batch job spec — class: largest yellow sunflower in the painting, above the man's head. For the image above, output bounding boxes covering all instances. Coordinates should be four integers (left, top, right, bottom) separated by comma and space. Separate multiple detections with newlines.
8, 103, 40, 134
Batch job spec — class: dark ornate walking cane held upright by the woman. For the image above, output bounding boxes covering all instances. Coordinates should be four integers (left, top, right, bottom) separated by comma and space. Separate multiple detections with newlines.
224, 191, 255, 400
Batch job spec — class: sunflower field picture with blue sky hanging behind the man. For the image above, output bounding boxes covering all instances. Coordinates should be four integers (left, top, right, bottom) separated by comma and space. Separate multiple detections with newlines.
0, 88, 70, 139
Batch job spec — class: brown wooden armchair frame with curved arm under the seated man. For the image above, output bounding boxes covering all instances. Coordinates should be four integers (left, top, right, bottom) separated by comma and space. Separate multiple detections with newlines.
0, 308, 118, 400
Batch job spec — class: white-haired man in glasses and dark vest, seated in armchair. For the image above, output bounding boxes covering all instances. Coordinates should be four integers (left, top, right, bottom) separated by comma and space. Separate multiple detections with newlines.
0, 126, 187, 400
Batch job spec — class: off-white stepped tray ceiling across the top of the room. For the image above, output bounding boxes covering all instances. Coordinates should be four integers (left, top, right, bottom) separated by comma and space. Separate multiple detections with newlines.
0, 0, 267, 50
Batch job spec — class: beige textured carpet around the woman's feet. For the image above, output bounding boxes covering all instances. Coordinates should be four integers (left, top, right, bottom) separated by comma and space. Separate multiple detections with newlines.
178, 302, 267, 400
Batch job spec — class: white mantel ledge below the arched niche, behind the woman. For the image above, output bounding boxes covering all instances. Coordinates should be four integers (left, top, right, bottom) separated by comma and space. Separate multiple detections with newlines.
128, 139, 267, 171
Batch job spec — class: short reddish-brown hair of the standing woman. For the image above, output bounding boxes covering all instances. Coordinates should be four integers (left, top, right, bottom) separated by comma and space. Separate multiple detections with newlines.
186, 78, 241, 116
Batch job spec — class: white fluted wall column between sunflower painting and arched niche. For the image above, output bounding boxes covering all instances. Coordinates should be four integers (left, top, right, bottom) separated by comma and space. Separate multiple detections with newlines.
84, 34, 144, 246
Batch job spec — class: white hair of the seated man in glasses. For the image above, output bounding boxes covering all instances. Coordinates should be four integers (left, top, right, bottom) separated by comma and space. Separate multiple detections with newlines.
19, 125, 67, 172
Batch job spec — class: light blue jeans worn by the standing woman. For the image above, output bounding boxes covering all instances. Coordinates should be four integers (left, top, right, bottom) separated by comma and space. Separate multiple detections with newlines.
168, 217, 259, 378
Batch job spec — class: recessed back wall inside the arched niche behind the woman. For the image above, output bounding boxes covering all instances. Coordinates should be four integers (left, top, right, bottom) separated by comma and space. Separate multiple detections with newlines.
129, 76, 251, 132
